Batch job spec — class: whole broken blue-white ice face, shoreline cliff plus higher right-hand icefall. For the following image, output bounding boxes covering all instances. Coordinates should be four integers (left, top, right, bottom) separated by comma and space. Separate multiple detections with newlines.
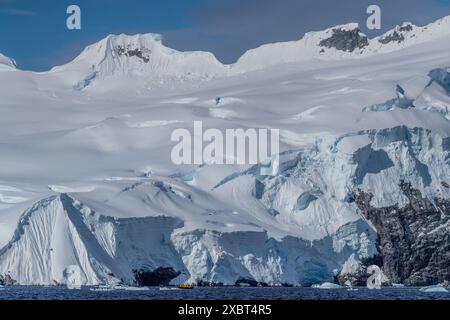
0, 127, 450, 285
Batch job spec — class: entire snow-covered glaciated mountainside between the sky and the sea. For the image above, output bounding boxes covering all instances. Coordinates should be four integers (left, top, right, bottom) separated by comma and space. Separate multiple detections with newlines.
0, 17, 450, 285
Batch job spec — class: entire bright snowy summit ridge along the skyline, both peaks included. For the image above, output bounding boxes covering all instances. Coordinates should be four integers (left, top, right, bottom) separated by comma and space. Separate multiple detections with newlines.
43, 17, 450, 90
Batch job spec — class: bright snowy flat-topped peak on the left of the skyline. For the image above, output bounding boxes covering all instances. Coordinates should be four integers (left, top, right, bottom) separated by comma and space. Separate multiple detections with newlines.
52, 34, 227, 90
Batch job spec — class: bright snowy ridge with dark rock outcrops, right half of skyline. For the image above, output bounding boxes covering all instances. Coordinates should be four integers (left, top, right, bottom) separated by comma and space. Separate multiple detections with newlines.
235, 17, 450, 71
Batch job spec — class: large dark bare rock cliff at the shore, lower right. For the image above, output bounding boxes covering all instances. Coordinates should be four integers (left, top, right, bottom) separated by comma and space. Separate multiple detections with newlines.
356, 181, 450, 286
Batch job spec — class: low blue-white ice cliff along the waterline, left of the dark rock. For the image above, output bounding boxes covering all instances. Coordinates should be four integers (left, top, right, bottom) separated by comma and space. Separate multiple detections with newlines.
0, 194, 376, 285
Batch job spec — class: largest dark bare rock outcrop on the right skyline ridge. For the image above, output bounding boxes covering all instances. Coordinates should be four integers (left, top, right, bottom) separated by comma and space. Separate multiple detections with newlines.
319, 29, 369, 52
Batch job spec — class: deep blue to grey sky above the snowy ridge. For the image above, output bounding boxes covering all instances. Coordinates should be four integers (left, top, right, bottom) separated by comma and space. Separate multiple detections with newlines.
0, 0, 450, 71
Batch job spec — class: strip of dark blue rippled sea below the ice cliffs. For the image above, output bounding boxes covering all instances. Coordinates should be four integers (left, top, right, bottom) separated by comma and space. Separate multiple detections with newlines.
0, 287, 450, 300
